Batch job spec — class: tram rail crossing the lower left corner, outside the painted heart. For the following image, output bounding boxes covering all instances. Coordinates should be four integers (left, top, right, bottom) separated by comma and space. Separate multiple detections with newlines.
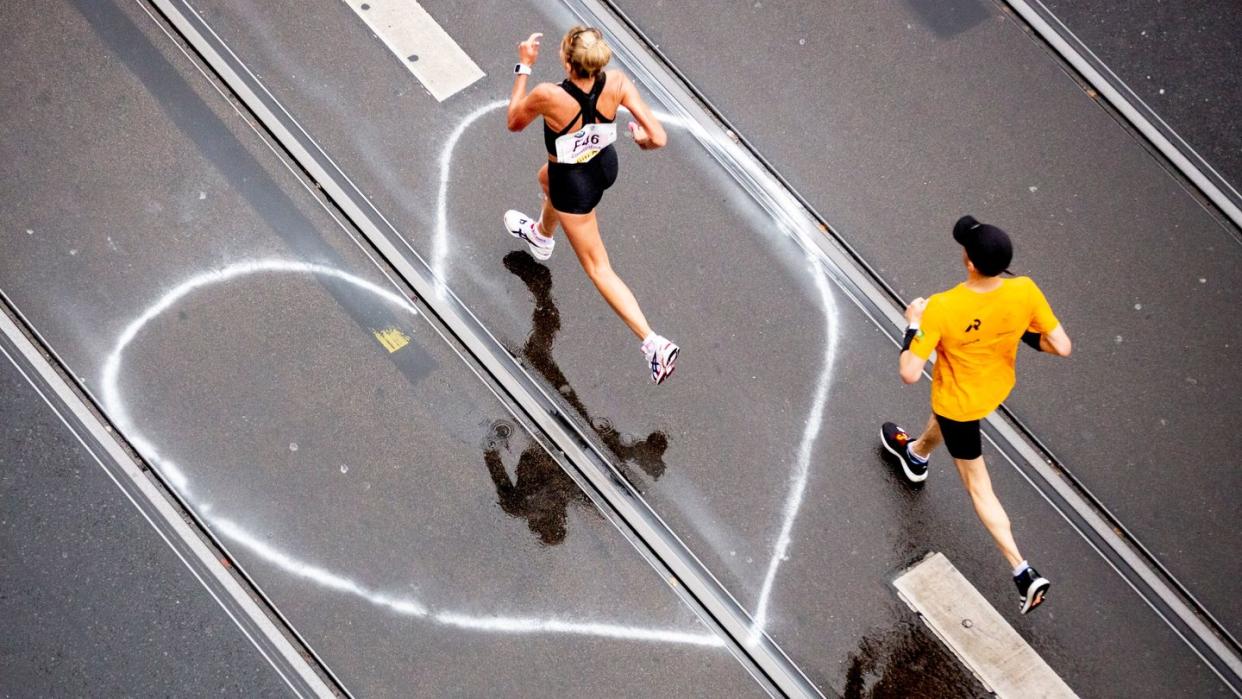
0, 310, 334, 698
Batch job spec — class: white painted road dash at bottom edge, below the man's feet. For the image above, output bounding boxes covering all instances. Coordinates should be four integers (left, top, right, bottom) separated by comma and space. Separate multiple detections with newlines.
893, 554, 1074, 698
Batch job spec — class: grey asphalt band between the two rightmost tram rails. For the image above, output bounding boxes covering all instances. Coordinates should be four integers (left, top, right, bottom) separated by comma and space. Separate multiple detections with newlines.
617, 0, 1242, 633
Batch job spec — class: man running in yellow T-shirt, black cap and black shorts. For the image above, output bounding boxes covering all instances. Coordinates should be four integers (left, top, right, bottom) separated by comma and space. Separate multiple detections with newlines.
881, 216, 1069, 615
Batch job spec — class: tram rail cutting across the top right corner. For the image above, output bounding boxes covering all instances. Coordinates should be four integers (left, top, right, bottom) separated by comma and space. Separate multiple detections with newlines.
1005, 0, 1242, 228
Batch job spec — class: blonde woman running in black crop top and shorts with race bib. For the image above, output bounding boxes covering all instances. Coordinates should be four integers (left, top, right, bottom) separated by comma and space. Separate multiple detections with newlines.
504, 26, 681, 384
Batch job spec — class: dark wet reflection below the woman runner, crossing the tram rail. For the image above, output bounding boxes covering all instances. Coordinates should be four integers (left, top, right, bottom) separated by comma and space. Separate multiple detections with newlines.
483, 251, 668, 545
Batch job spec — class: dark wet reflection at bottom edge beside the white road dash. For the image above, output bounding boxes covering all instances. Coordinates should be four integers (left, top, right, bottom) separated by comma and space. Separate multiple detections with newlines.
843, 618, 991, 699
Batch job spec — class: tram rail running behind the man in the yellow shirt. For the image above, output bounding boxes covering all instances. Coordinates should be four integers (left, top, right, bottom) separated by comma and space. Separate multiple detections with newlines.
566, 0, 1242, 695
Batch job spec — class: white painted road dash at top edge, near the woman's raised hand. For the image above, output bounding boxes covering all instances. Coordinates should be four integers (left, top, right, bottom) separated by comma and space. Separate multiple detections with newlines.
345, 0, 484, 102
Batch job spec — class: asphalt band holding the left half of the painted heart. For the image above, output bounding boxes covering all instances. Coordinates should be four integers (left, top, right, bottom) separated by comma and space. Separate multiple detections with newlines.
0, 2, 759, 695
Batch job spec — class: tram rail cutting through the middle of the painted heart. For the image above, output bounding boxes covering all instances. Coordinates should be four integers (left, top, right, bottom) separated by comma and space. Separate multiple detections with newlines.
138, 0, 820, 697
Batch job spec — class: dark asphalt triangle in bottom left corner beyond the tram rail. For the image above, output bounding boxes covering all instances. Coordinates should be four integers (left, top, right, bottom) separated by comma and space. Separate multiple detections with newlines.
0, 345, 288, 697
